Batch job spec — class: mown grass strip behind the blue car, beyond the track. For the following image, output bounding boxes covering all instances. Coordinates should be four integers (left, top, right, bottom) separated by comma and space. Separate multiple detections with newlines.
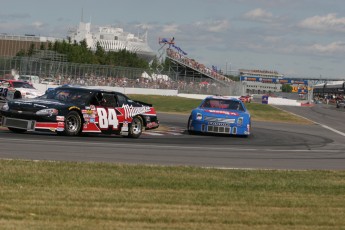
129, 94, 311, 124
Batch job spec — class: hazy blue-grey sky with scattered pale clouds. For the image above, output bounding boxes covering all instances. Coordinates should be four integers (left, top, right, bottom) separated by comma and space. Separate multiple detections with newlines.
0, 0, 345, 79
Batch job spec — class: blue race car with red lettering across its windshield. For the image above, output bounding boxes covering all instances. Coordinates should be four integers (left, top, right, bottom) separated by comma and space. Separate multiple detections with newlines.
187, 96, 251, 136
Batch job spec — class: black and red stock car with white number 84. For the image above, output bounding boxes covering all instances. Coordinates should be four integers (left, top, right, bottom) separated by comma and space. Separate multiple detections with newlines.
0, 86, 159, 138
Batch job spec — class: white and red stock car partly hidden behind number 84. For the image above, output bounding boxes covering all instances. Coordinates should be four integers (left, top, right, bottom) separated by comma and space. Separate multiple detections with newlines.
0, 80, 44, 100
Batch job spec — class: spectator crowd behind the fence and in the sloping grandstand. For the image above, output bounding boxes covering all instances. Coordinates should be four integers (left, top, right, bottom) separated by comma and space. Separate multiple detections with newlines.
4, 48, 238, 94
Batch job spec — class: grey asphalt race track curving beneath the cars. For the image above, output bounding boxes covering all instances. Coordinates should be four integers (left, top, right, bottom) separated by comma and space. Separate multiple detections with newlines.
0, 105, 345, 170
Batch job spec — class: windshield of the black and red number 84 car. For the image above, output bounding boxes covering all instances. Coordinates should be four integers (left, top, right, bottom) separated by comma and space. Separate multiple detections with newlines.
41, 89, 92, 104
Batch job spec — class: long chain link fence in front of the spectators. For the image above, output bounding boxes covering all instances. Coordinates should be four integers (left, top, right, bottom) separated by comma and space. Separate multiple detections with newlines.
0, 57, 243, 95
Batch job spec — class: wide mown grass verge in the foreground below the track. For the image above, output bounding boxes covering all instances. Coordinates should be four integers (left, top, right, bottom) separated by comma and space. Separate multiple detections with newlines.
0, 160, 345, 230
